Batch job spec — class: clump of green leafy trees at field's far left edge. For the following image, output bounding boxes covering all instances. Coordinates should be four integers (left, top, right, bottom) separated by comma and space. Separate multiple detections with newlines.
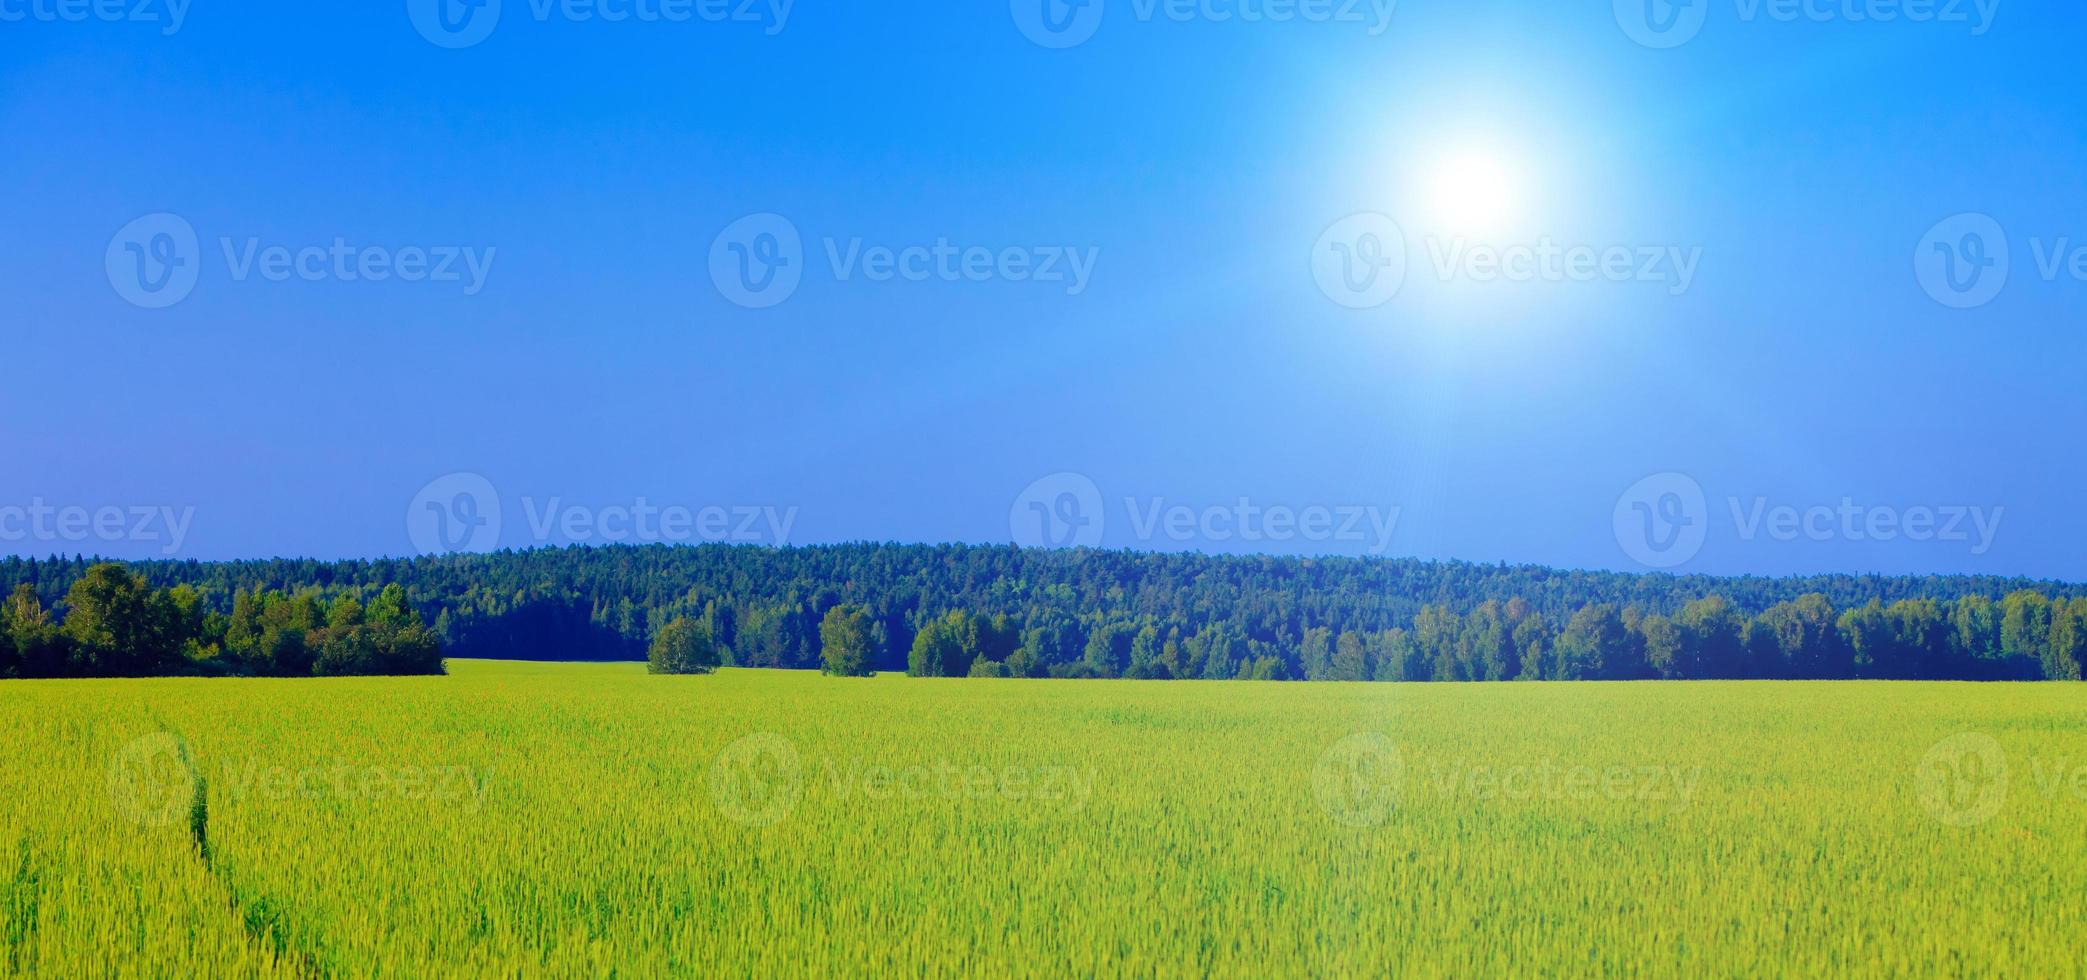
0, 563, 442, 678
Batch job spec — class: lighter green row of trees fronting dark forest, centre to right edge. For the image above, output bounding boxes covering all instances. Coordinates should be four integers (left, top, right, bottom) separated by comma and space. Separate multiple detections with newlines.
651, 590, 2087, 682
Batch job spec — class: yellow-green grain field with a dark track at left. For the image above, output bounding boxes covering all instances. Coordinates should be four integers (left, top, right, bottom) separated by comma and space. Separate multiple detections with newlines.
0, 661, 2087, 976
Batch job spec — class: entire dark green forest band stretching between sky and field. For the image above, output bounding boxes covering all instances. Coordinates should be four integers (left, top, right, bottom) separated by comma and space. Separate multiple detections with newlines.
0, 544, 2087, 682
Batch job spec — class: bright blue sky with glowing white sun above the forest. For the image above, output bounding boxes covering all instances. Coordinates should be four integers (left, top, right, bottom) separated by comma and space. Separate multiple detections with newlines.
0, 0, 2087, 580
